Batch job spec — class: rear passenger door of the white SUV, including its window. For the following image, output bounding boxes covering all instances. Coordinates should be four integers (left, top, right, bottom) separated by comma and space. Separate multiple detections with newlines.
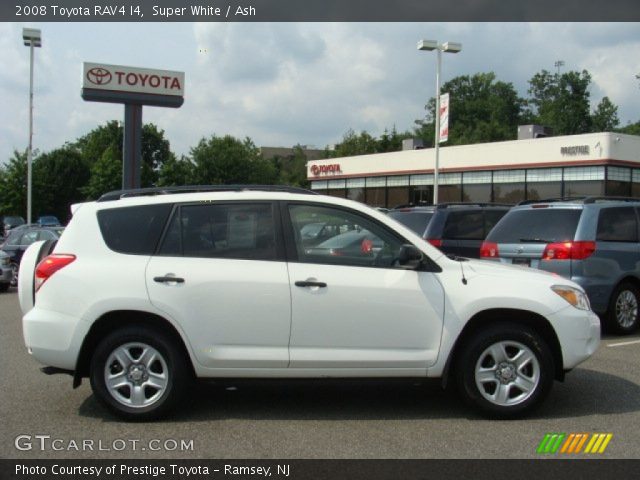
146, 202, 291, 368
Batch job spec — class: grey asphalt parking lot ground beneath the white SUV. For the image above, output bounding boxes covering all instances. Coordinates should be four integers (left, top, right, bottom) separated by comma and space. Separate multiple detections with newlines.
0, 291, 640, 459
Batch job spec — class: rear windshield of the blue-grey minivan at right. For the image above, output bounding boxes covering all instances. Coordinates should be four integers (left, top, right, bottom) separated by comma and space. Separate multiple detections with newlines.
487, 208, 582, 243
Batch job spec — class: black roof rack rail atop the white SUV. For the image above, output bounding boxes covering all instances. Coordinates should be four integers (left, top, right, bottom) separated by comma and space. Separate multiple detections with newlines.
98, 185, 318, 202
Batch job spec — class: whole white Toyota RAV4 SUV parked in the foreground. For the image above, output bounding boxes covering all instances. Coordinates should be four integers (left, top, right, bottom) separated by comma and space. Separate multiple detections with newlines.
19, 186, 600, 419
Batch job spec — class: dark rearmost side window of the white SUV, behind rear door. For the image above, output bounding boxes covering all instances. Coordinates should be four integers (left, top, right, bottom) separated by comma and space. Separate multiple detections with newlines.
98, 204, 173, 255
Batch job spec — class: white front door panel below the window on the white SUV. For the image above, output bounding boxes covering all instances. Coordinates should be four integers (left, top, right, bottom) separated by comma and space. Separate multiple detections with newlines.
289, 263, 444, 368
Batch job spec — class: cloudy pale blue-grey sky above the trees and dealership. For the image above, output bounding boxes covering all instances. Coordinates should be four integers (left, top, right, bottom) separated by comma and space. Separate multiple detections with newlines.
0, 22, 640, 163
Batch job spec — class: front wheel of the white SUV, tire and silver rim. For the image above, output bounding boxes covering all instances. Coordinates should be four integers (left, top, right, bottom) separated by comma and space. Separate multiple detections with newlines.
455, 322, 554, 419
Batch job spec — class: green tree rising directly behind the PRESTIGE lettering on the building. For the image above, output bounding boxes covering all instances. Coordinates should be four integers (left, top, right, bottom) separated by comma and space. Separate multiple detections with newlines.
529, 70, 592, 135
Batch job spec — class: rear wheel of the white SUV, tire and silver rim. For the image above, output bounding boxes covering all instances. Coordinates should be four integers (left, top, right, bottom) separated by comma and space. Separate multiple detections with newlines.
89, 326, 192, 421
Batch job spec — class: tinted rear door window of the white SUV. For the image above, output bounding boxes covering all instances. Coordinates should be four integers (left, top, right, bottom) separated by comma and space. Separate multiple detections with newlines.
158, 204, 277, 260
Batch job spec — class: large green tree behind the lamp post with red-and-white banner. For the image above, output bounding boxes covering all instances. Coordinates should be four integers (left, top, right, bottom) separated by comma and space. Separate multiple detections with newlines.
415, 72, 525, 146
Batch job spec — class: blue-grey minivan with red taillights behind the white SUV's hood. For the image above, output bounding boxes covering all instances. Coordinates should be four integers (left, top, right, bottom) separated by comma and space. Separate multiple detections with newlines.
481, 197, 640, 334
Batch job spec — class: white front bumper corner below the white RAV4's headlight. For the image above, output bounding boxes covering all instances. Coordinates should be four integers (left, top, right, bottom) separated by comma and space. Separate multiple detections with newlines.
549, 307, 600, 370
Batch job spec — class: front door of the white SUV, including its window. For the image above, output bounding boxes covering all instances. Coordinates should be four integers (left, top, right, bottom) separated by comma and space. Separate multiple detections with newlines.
284, 204, 444, 369
